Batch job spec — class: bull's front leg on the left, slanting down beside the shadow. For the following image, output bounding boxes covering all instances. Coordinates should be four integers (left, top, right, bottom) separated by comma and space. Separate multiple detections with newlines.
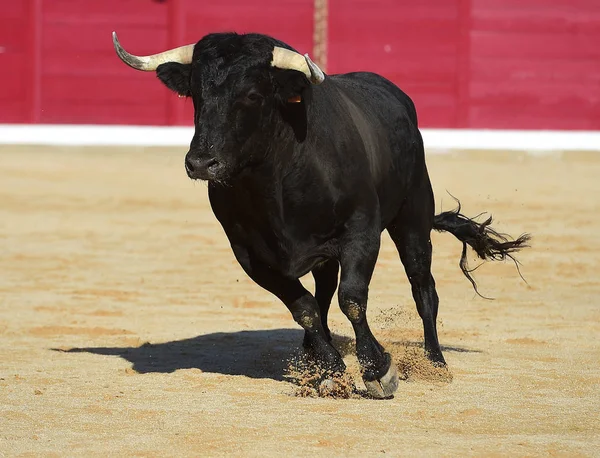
232, 245, 346, 373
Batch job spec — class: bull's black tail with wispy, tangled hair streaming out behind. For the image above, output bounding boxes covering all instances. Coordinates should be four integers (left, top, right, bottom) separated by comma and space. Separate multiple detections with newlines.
433, 202, 531, 297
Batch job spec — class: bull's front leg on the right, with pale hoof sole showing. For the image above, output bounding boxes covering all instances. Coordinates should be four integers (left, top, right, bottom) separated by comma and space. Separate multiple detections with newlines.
338, 227, 398, 398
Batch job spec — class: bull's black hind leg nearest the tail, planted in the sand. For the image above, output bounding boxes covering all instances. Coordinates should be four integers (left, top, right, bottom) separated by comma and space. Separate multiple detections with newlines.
387, 179, 446, 365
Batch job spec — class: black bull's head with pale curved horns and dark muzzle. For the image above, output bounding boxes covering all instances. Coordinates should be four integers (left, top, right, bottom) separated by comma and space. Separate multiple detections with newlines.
113, 32, 325, 182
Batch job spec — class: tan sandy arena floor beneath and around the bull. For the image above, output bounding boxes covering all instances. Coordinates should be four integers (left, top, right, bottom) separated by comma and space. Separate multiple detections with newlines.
0, 147, 600, 457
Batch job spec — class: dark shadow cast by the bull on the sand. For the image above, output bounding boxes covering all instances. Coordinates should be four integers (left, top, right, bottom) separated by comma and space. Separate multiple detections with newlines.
53, 329, 480, 381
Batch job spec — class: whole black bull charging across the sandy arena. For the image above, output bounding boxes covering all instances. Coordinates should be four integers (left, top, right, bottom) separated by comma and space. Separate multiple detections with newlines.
115, 33, 528, 397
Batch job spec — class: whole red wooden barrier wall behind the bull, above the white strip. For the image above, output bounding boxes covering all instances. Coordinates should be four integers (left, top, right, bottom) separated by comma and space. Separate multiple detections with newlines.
0, 0, 600, 129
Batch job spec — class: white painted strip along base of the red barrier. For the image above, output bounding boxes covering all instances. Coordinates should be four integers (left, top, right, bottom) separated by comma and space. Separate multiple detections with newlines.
0, 124, 600, 153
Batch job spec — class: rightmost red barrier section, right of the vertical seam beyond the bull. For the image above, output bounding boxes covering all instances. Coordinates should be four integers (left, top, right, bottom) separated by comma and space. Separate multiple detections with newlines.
465, 0, 600, 129
